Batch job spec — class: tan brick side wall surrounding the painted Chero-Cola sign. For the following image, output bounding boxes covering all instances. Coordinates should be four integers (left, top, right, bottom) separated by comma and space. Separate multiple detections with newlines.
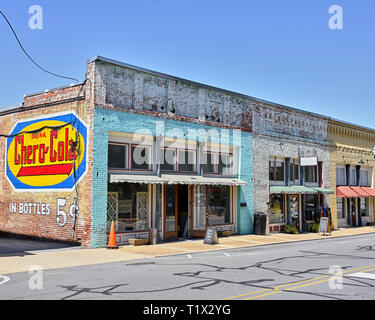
0, 95, 92, 246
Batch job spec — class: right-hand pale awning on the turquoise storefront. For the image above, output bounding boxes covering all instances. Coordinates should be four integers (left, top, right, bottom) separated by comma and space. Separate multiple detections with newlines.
161, 174, 247, 186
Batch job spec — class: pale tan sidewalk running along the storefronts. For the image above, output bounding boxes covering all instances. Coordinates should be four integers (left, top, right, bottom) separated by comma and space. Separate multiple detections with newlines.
0, 226, 375, 275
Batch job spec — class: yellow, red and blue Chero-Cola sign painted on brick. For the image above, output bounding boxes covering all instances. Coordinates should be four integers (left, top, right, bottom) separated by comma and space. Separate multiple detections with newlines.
6, 113, 87, 191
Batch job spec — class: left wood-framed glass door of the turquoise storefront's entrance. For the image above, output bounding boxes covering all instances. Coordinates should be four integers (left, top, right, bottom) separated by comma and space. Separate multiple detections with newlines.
164, 185, 178, 239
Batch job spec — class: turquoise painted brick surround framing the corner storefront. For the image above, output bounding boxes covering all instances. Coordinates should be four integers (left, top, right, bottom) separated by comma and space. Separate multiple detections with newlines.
91, 108, 253, 248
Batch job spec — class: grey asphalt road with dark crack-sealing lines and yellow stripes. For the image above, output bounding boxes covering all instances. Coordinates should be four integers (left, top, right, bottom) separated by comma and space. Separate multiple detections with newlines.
0, 234, 375, 300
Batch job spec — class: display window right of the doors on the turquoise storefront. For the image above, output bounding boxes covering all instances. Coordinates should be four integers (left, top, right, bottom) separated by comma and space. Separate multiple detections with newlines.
207, 186, 231, 225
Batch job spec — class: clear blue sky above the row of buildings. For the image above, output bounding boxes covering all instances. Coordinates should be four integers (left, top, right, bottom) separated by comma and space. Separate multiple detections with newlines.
0, 0, 375, 128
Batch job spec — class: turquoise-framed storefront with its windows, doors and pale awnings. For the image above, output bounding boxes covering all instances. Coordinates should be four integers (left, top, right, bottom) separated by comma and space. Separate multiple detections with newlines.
93, 108, 252, 244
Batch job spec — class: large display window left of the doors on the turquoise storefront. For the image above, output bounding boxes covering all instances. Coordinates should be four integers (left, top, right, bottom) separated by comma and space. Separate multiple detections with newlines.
108, 183, 149, 232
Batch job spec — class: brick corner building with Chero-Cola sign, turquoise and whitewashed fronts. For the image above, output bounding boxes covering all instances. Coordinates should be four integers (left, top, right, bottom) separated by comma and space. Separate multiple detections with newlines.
0, 57, 374, 247
